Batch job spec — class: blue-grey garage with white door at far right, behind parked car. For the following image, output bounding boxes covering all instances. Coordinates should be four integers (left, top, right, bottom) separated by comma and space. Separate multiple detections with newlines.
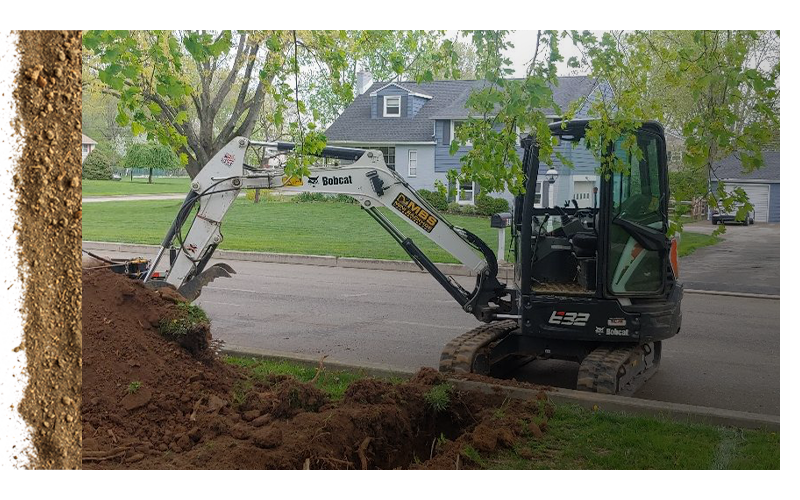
712, 151, 781, 222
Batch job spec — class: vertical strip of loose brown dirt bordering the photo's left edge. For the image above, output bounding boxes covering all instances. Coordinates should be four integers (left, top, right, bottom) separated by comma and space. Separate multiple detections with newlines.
13, 30, 81, 469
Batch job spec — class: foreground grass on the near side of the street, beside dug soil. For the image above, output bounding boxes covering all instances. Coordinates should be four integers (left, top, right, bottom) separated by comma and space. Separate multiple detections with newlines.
226, 357, 781, 470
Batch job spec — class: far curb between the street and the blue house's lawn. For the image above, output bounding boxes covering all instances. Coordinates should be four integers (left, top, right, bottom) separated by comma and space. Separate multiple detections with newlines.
83, 241, 514, 280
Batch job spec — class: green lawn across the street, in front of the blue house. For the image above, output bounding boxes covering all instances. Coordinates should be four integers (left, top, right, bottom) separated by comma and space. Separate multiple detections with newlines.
83, 199, 511, 263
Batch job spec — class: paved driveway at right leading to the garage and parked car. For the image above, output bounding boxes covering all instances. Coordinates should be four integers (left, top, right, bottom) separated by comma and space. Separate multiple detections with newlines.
680, 222, 781, 295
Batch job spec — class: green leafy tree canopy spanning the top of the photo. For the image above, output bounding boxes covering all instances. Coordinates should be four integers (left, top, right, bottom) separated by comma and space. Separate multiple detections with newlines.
84, 30, 780, 227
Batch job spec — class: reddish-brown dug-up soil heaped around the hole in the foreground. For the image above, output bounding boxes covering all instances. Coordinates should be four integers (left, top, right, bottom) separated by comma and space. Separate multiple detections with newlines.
82, 270, 552, 469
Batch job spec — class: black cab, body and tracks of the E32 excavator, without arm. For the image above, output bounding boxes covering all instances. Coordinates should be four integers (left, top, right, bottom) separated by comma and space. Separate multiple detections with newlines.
442, 120, 682, 393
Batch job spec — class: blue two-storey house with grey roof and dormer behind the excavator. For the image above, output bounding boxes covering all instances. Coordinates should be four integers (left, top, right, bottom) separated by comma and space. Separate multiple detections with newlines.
326, 74, 599, 206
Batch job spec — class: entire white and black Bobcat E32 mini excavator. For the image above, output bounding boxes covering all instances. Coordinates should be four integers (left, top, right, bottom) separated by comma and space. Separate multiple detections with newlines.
125, 120, 683, 394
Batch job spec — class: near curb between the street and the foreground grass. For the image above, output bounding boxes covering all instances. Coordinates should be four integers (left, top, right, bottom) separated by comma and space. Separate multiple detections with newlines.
222, 346, 781, 432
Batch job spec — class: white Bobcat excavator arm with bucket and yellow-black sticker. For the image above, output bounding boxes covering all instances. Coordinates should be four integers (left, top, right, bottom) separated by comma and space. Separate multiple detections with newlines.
144, 137, 511, 322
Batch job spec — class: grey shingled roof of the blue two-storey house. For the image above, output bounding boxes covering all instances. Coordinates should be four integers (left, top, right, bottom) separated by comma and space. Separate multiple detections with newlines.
325, 76, 596, 143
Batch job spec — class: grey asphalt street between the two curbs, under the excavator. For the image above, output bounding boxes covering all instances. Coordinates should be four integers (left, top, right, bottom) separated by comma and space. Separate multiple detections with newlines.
89, 248, 780, 415
